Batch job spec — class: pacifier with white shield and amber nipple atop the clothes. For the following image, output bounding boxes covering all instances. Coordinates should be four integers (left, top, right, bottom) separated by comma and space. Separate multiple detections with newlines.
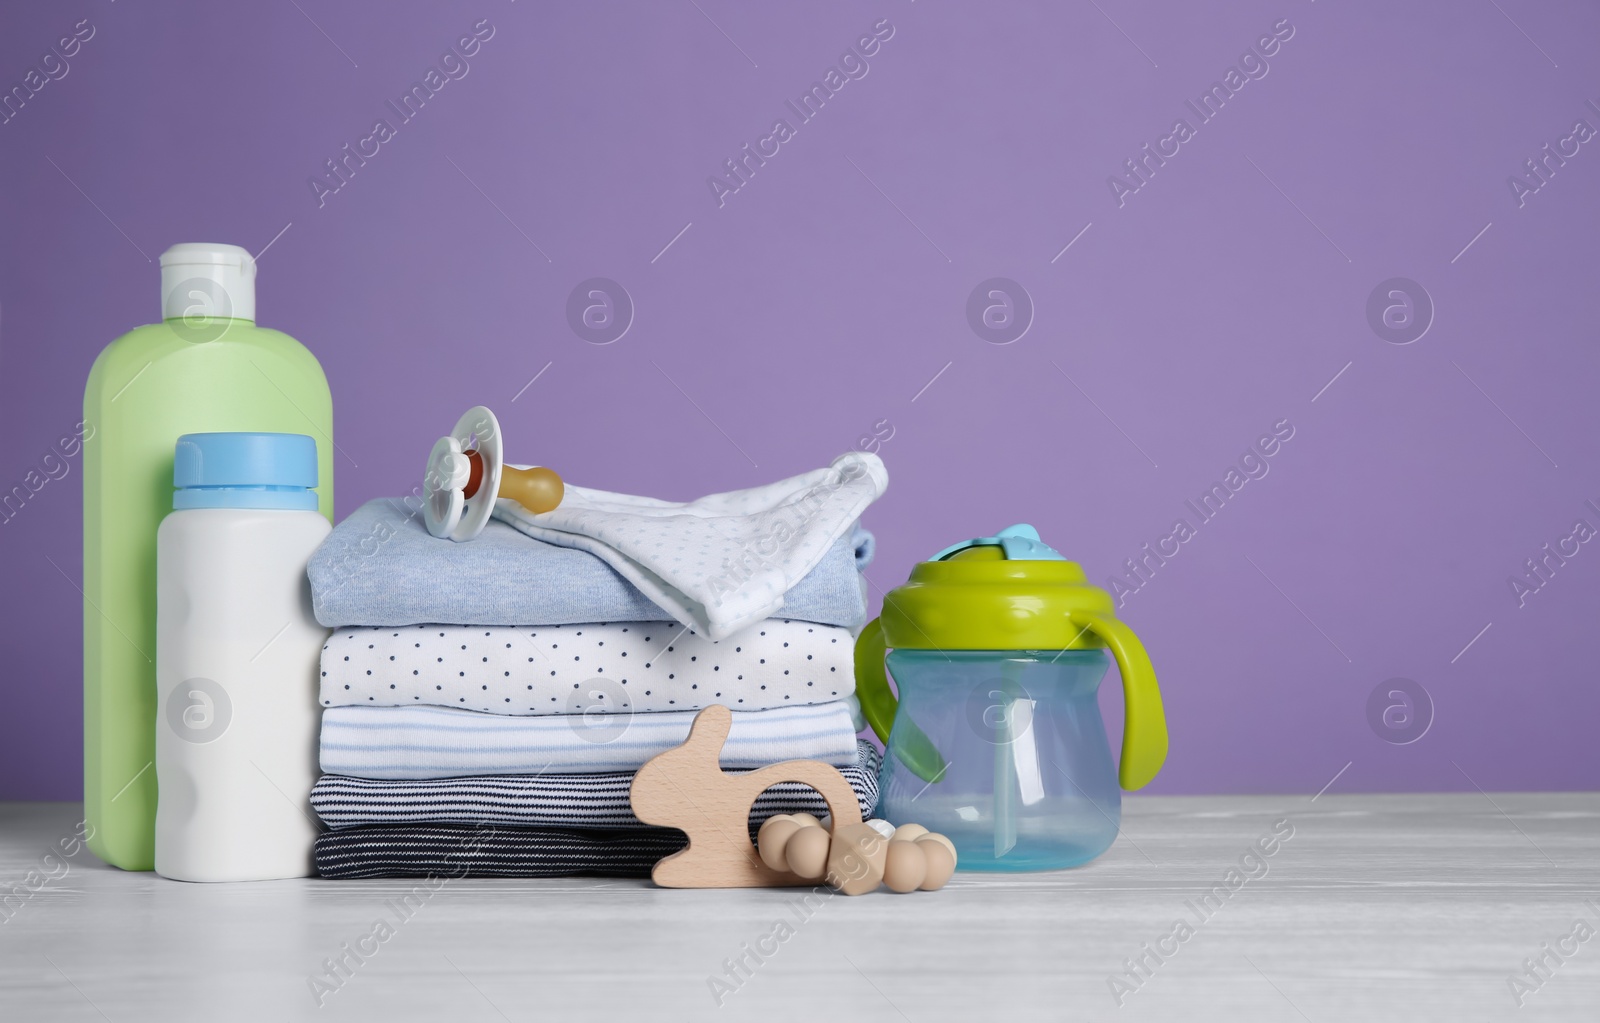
422, 405, 565, 543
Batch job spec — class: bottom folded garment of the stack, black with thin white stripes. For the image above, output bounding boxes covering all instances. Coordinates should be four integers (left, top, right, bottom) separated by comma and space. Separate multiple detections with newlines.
317, 824, 688, 881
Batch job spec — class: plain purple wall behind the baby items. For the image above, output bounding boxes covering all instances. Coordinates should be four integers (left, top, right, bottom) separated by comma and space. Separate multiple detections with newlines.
0, 0, 1600, 799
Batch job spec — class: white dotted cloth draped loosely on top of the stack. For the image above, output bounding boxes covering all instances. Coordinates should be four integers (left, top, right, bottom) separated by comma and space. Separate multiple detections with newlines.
494, 451, 890, 640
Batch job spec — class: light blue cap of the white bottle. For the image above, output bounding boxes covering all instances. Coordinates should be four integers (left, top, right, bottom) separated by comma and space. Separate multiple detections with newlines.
173, 434, 317, 511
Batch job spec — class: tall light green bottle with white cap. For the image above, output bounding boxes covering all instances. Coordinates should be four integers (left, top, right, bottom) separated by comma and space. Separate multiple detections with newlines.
82, 243, 333, 871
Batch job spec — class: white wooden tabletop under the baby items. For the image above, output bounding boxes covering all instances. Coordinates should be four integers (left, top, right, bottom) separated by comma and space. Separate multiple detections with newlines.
0, 794, 1600, 1023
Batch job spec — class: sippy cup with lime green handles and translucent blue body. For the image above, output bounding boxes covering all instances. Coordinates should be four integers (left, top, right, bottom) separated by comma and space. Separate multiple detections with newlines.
856, 525, 1166, 871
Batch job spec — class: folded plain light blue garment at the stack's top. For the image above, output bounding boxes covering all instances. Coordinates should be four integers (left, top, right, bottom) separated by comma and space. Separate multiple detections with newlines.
307, 498, 874, 628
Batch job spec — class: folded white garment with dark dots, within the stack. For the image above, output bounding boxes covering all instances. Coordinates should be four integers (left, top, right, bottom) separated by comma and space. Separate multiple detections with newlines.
320, 618, 856, 716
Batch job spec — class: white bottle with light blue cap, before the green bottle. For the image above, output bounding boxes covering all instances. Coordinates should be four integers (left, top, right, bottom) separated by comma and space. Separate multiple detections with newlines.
155, 434, 330, 881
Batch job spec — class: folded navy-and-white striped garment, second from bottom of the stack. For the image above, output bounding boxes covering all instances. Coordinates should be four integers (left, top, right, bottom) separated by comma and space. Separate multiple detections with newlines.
310, 740, 880, 831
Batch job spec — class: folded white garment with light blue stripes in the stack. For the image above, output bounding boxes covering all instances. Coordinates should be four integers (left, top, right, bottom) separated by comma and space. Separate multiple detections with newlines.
322, 701, 856, 780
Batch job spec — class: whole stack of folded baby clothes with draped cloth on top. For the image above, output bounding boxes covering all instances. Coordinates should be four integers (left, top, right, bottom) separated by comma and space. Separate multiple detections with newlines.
300, 453, 886, 877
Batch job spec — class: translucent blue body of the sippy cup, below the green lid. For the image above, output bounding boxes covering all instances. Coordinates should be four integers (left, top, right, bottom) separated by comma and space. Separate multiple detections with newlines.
878, 650, 1122, 871
